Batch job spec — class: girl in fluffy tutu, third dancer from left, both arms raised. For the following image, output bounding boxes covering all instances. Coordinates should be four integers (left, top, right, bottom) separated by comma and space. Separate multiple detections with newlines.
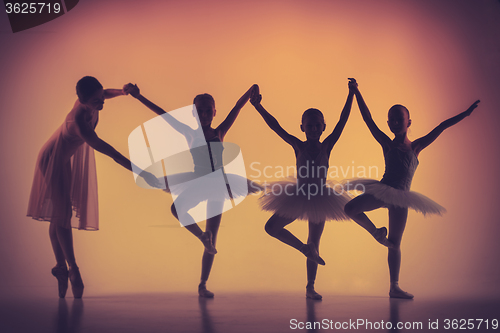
250, 80, 354, 299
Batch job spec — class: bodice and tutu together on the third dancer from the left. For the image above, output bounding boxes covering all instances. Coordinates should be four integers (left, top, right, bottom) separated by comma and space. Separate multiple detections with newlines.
259, 145, 351, 223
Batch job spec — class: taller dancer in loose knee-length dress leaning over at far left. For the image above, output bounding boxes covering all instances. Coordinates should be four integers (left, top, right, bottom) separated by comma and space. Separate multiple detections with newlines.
27, 76, 160, 298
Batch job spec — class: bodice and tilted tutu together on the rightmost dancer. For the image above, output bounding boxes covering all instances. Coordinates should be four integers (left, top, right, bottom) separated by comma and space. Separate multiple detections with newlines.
344, 148, 446, 215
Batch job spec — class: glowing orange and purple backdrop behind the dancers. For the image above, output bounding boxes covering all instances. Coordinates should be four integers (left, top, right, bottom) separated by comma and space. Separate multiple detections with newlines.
0, 0, 500, 295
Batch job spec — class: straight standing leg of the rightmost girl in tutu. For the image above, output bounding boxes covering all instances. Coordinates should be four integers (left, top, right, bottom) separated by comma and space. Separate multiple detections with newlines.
387, 207, 413, 298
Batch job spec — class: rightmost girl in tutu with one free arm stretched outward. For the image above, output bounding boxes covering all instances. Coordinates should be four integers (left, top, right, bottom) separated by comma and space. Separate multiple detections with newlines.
344, 83, 479, 298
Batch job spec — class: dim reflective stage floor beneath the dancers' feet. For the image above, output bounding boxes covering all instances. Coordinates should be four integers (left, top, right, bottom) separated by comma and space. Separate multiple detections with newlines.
0, 292, 500, 333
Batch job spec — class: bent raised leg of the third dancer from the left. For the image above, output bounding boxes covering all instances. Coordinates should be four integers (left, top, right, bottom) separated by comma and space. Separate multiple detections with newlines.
265, 214, 325, 265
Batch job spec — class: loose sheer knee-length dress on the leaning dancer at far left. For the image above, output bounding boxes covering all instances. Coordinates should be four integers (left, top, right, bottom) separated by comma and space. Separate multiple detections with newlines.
27, 101, 99, 230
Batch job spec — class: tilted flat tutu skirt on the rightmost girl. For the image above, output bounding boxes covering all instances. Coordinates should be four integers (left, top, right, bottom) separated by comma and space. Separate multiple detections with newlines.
342, 179, 446, 215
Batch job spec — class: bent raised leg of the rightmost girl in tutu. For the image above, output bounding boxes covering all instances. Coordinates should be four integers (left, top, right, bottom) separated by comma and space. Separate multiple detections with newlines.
344, 194, 392, 247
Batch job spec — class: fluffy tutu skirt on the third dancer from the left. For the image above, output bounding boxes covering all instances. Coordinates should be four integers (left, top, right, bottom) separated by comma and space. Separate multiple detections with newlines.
259, 177, 351, 223
